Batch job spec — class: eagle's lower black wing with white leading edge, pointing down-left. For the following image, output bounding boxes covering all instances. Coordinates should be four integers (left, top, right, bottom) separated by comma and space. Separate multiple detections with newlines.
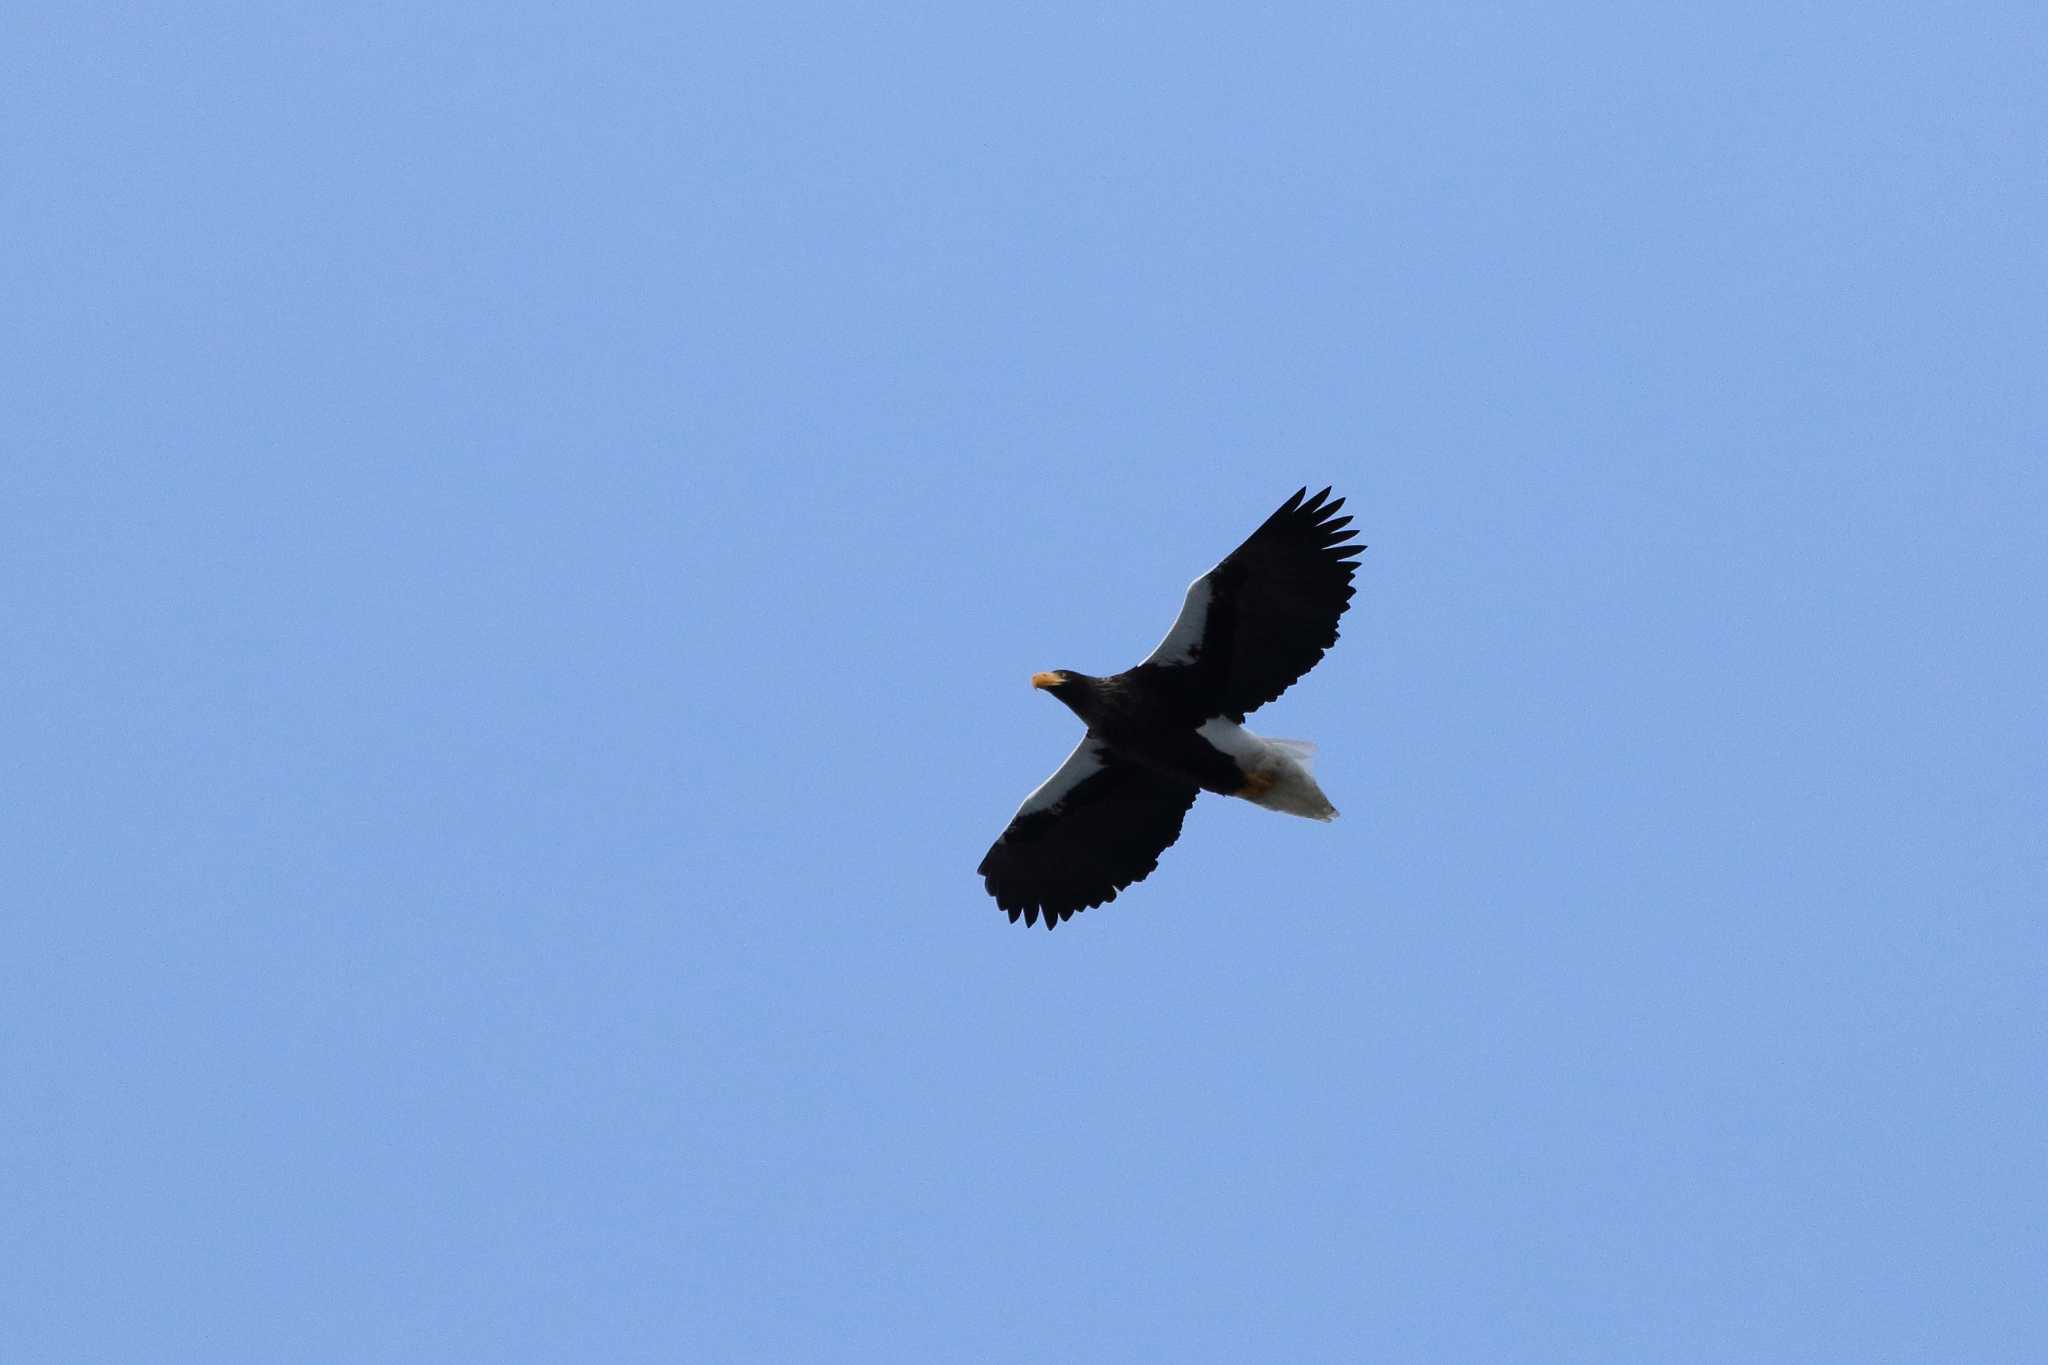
979, 735, 1200, 929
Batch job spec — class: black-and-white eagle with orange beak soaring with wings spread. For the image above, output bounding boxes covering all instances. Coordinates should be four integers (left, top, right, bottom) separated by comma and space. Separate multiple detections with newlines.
979, 487, 1366, 929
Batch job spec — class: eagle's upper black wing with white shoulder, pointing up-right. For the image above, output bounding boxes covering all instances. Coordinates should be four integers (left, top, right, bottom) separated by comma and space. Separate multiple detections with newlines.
1141, 489, 1366, 720
